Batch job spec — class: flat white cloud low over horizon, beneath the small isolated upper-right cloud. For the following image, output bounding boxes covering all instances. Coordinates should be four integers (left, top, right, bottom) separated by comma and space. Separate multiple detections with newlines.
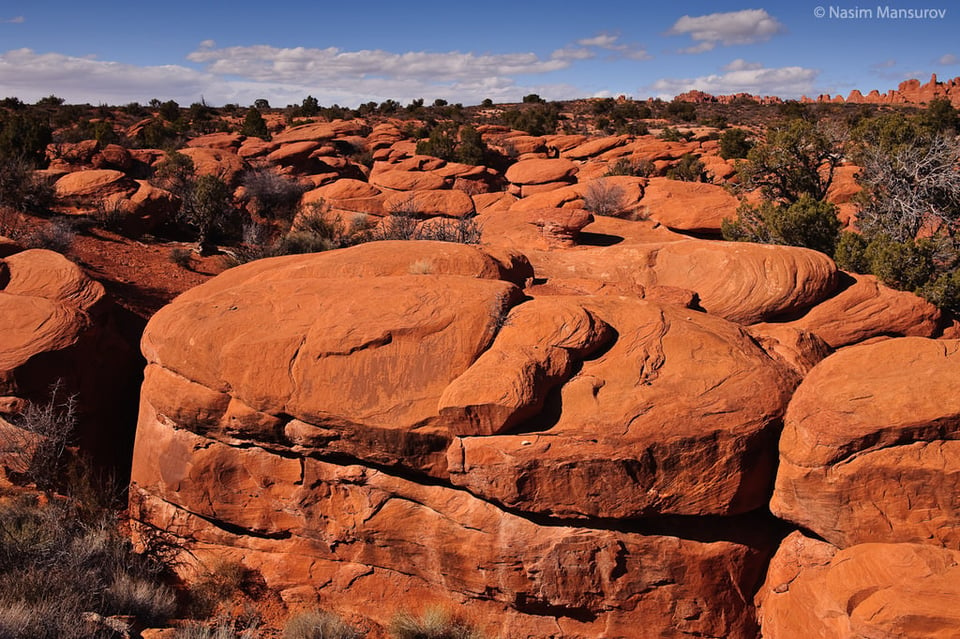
646, 65, 820, 98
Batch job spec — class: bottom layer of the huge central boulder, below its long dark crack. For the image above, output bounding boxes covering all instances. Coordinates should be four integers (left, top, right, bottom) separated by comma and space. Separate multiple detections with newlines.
132, 420, 765, 639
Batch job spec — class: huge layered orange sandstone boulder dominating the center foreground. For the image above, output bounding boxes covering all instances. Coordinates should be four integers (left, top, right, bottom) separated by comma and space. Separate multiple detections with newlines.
132, 242, 799, 637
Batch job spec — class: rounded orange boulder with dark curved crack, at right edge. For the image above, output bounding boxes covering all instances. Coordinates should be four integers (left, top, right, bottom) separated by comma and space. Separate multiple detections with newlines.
770, 337, 960, 549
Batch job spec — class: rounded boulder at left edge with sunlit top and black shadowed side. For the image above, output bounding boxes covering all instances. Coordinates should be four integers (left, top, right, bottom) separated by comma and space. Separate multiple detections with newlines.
0, 249, 142, 474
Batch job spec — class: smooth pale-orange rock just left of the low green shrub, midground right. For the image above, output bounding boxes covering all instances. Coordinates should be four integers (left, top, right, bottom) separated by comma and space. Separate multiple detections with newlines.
640, 178, 739, 233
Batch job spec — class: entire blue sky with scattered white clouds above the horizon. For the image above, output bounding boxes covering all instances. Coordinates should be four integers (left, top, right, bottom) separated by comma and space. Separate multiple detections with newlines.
0, 0, 960, 106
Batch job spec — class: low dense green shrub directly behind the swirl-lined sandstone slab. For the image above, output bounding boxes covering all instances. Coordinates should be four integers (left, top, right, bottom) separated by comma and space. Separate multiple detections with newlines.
722, 195, 840, 255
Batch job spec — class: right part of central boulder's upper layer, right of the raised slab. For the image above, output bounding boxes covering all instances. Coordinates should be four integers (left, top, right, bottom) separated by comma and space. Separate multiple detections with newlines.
448, 297, 796, 518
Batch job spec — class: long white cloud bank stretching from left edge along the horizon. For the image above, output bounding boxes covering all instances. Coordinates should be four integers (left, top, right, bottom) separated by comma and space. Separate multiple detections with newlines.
0, 42, 587, 106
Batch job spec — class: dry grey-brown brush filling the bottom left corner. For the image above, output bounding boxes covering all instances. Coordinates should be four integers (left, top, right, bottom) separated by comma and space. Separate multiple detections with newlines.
0, 495, 175, 639
